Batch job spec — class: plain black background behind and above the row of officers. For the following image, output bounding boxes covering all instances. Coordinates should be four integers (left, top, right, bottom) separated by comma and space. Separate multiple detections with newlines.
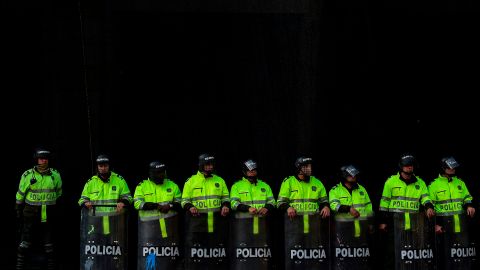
1, 0, 480, 269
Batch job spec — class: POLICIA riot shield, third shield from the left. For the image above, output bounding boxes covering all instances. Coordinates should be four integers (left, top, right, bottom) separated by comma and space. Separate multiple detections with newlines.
185, 212, 229, 270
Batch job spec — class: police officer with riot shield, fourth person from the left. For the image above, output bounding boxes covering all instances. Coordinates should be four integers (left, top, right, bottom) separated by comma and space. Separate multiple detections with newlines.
182, 154, 230, 269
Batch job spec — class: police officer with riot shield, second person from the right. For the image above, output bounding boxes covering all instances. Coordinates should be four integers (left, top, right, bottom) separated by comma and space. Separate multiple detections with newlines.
379, 154, 435, 269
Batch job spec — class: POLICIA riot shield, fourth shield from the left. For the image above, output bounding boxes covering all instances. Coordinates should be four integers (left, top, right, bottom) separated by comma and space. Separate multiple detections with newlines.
230, 212, 272, 270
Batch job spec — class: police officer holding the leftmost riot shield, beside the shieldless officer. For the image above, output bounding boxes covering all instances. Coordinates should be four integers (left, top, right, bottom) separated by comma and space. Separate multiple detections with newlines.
78, 155, 133, 269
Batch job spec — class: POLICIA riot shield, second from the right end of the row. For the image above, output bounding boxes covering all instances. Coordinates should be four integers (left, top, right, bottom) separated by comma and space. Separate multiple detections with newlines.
393, 212, 435, 270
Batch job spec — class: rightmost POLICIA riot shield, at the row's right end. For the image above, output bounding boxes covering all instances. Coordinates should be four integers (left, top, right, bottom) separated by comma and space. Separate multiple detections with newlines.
436, 214, 476, 270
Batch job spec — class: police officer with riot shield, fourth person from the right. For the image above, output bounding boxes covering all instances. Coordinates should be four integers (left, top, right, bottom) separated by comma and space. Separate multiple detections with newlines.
278, 157, 330, 270
